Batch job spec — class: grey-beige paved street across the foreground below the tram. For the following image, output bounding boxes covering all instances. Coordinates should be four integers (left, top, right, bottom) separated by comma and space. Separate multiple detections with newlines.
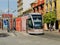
0, 31, 60, 45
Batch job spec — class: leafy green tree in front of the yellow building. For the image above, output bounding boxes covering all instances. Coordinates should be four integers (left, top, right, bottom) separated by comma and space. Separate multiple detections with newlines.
43, 11, 56, 29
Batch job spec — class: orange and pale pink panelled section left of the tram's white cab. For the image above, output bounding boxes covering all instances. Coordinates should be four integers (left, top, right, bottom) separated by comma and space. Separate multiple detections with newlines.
16, 16, 28, 32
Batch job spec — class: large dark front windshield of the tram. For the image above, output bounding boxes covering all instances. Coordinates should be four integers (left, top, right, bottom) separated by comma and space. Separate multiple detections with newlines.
32, 15, 42, 29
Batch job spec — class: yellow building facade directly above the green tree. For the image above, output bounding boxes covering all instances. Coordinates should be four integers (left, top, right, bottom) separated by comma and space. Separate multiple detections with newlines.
45, 0, 56, 12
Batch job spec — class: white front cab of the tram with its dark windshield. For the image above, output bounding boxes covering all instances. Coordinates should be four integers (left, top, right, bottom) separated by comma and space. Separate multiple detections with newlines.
26, 13, 44, 34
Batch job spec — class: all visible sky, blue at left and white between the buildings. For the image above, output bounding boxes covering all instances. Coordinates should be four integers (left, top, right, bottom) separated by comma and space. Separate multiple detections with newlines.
0, 0, 34, 16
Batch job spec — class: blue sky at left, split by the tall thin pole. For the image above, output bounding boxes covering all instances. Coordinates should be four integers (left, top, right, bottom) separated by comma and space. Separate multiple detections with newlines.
0, 0, 17, 15
